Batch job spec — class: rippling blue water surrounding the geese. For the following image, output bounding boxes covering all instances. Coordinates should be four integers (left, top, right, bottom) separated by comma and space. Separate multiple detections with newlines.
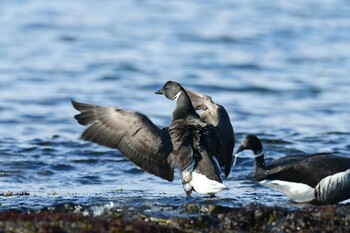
0, 0, 350, 209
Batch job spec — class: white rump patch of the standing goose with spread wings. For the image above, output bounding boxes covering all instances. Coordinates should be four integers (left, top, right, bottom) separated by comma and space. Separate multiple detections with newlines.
190, 171, 229, 195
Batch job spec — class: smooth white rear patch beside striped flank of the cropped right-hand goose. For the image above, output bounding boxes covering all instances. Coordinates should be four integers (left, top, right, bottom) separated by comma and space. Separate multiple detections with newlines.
259, 180, 315, 202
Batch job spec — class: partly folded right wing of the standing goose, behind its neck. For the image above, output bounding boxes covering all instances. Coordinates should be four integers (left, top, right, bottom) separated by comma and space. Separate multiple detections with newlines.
186, 89, 235, 176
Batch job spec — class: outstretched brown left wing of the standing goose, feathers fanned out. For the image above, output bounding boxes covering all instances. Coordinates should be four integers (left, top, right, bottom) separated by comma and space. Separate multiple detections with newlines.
72, 100, 174, 181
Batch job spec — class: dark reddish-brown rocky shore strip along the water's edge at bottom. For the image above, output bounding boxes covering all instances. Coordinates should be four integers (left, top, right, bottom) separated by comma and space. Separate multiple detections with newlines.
0, 203, 350, 233
